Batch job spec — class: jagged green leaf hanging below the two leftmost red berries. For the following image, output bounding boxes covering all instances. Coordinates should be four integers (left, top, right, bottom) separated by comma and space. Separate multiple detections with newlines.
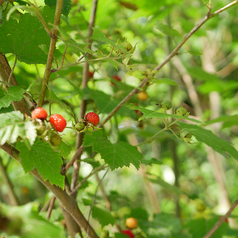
17, 140, 64, 188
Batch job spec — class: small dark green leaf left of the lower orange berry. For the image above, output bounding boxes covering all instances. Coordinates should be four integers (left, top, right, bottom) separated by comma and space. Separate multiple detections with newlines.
92, 206, 116, 227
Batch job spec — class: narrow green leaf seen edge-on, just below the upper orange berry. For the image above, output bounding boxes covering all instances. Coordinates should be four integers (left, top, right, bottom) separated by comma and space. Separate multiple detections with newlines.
128, 103, 202, 123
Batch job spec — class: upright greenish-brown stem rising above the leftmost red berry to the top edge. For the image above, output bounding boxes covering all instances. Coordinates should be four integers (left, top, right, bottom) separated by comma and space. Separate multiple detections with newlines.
37, 0, 63, 107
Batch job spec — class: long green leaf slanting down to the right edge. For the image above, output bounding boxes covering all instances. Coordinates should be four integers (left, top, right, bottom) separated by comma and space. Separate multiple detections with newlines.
178, 122, 238, 160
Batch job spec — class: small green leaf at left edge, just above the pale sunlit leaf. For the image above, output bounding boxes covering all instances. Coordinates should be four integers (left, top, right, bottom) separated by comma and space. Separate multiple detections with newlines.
0, 86, 25, 109
